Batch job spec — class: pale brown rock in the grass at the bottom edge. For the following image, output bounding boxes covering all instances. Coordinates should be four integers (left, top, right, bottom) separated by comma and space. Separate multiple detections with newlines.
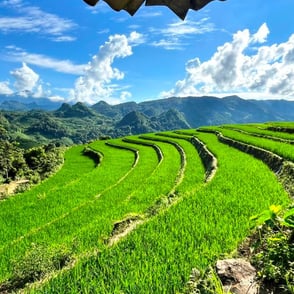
216, 258, 259, 294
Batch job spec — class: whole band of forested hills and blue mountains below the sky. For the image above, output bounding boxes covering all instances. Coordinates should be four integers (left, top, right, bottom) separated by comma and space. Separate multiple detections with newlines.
0, 96, 294, 148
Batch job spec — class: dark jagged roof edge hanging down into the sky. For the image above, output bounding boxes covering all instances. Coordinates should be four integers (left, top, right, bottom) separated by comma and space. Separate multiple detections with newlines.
84, 0, 225, 20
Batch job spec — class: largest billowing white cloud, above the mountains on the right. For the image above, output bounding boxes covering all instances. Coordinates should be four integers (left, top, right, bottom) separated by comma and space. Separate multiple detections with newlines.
161, 24, 294, 98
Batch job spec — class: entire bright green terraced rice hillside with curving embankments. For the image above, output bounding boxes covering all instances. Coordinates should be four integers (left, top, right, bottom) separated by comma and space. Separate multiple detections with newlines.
0, 124, 294, 293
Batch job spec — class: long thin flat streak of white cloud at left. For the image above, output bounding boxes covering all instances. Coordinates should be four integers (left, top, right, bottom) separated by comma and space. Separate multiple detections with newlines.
1, 46, 86, 75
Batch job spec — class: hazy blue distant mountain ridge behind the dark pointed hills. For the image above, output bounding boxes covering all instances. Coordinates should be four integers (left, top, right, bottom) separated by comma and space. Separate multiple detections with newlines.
92, 96, 294, 127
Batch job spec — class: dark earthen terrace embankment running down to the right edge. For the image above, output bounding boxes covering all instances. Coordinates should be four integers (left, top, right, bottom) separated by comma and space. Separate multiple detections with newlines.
216, 132, 294, 198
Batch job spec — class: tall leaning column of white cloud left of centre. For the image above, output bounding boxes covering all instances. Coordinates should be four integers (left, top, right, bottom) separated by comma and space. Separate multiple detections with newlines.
71, 33, 135, 104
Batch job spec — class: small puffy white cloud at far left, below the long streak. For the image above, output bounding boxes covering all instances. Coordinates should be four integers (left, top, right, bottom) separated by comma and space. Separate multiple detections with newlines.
10, 63, 39, 92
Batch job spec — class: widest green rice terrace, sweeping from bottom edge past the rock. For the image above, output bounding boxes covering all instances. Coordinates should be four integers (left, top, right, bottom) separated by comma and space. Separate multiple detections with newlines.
30, 133, 289, 293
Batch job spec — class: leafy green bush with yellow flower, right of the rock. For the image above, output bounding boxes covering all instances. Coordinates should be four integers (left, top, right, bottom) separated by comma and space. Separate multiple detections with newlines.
252, 205, 294, 293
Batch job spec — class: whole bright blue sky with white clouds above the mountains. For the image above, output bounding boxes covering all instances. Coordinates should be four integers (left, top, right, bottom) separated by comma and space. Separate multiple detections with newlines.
0, 0, 294, 104
